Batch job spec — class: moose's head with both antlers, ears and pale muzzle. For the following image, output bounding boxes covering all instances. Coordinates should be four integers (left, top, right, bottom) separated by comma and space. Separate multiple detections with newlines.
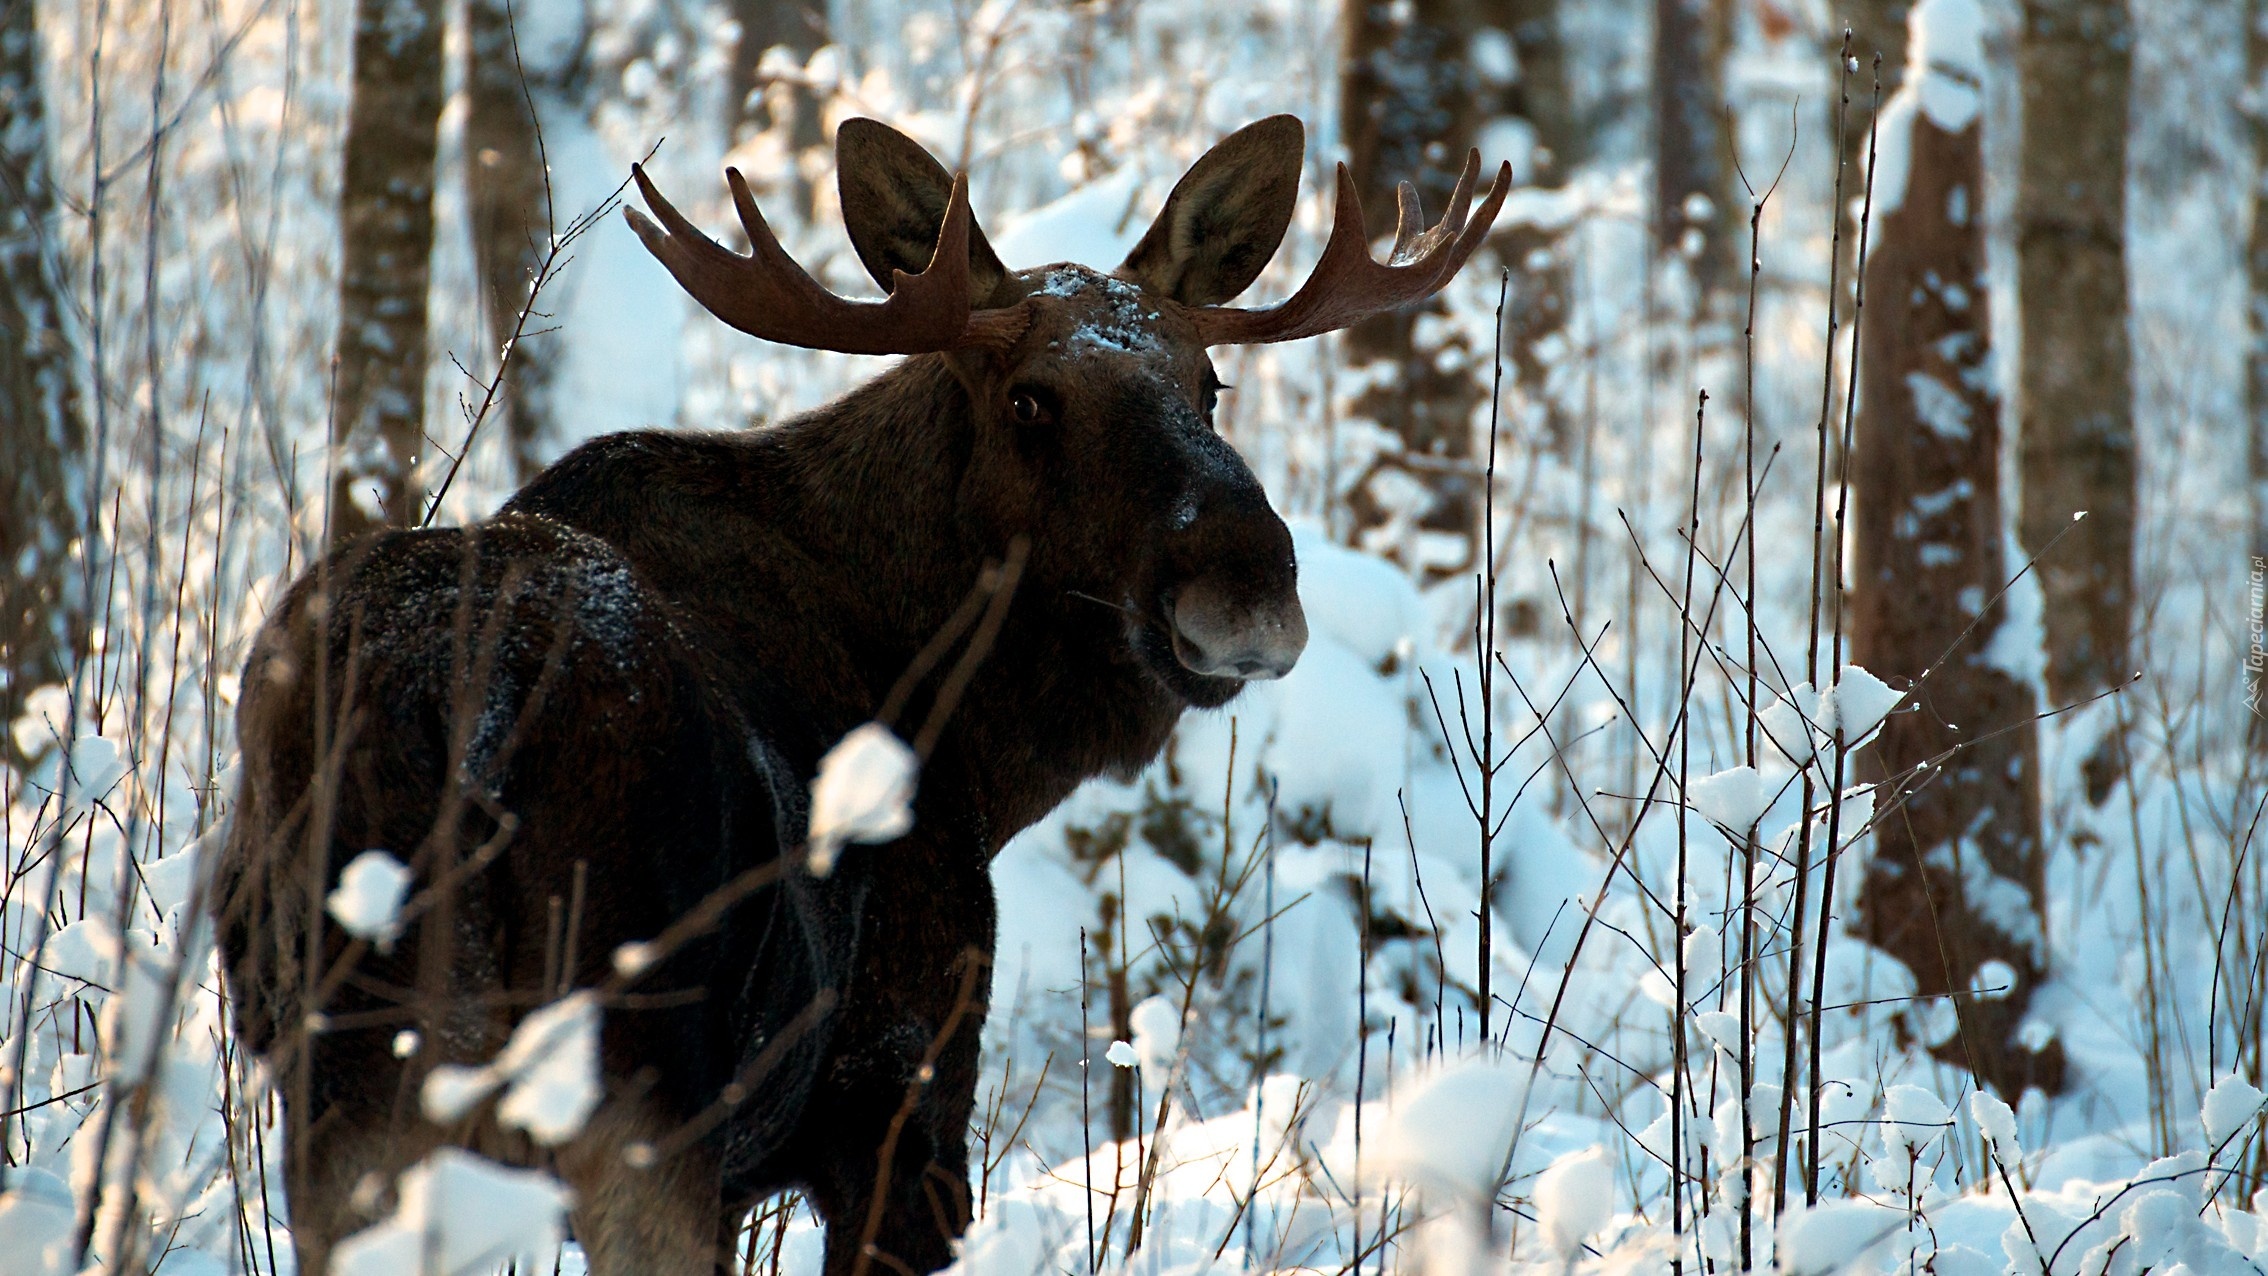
626, 116, 1510, 707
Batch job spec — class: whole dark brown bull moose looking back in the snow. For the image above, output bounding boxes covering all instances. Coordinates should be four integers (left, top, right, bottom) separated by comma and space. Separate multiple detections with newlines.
215, 116, 1510, 1276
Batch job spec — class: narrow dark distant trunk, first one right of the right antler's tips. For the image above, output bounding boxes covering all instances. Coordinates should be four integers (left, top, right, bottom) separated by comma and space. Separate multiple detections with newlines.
1653, 0, 1749, 299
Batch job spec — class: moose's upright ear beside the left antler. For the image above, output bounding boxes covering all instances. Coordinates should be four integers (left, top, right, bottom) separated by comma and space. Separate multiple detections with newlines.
835, 118, 1007, 308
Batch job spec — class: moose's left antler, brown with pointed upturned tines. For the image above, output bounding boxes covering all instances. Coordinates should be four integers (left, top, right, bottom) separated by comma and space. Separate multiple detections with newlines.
621, 163, 1018, 354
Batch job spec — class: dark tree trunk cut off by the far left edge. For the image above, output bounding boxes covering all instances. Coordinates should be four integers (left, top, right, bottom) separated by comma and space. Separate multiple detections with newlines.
0, 0, 84, 723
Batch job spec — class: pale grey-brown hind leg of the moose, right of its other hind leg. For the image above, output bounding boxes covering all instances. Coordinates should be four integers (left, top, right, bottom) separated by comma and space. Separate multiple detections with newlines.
558, 1099, 733, 1276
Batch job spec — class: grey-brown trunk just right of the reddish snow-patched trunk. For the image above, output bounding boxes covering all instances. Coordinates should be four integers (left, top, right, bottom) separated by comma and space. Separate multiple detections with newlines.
2016, 0, 2134, 703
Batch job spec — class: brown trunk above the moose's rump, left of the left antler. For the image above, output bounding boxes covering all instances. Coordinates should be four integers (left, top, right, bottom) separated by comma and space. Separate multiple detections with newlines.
331, 0, 445, 539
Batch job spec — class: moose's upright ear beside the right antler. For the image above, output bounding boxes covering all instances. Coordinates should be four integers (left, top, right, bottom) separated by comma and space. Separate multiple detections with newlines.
1118, 116, 1306, 306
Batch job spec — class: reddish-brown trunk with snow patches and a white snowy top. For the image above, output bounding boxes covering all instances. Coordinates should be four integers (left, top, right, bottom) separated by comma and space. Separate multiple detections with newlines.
1851, 0, 2064, 1097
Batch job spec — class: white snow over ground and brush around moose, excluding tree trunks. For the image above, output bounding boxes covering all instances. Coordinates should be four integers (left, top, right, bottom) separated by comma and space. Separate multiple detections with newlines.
0, 0, 2268, 1276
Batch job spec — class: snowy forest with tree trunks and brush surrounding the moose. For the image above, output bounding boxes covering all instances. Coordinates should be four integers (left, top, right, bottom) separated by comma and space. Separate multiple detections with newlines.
0, 0, 2268, 1276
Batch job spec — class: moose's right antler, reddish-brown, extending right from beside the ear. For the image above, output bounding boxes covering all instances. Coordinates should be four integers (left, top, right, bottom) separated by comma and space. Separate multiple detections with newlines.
1186, 150, 1513, 344
